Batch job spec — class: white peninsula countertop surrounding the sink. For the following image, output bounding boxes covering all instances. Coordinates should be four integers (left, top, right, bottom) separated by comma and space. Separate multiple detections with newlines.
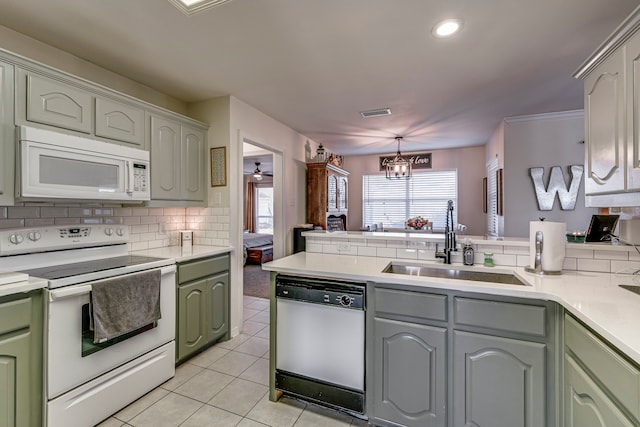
262, 252, 640, 364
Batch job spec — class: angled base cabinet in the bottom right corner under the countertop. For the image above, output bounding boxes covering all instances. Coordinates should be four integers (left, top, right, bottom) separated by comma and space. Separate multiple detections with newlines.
564, 315, 640, 427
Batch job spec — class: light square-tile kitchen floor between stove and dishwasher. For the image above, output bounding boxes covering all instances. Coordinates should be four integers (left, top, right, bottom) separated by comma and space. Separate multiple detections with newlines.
99, 296, 368, 427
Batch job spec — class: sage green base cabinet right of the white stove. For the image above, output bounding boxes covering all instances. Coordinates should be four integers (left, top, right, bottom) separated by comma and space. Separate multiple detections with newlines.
176, 254, 229, 362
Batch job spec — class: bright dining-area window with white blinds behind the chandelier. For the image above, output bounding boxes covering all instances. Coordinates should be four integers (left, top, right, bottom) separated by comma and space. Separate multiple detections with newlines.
362, 170, 458, 230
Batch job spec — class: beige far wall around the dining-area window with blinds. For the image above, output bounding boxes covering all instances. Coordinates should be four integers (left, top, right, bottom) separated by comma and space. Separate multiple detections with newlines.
344, 146, 486, 235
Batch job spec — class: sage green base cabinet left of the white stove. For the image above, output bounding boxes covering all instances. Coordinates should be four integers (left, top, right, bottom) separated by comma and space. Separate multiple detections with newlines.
0, 291, 43, 427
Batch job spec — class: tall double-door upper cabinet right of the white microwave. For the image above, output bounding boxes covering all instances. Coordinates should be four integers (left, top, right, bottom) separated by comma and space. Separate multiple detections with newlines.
151, 116, 207, 206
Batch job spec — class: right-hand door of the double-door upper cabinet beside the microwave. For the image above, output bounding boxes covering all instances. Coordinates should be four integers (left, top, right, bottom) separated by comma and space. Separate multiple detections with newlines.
180, 125, 207, 201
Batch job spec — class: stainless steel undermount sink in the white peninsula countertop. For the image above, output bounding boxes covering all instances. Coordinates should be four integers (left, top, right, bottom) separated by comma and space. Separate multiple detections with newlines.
382, 262, 527, 286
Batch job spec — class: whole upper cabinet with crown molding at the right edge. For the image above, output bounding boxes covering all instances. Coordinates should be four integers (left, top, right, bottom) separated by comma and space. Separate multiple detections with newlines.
574, 9, 640, 207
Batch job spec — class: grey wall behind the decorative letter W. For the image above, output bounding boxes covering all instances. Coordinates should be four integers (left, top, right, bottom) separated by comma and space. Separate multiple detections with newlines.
504, 111, 597, 237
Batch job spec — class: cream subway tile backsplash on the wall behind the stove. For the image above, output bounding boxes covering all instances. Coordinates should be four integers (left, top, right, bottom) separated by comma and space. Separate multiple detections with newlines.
0, 203, 229, 250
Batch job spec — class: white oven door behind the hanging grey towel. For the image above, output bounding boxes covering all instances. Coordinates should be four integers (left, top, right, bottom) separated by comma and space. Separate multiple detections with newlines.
45, 266, 176, 400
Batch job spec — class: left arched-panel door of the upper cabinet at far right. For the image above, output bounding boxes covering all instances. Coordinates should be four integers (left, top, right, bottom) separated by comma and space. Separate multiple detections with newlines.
585, 51, 625, 194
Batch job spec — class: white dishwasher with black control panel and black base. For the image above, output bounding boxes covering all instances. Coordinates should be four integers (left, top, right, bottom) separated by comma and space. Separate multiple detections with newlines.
276, 275, 365, 414
